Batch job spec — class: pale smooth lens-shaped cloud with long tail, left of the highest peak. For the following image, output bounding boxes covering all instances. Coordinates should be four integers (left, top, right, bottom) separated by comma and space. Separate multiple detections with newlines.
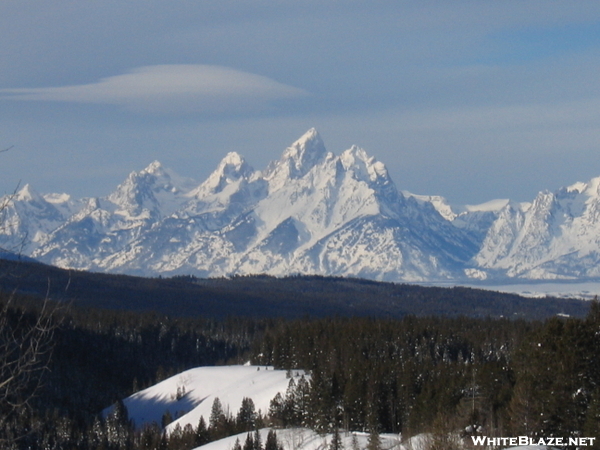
0, 65, 309, 113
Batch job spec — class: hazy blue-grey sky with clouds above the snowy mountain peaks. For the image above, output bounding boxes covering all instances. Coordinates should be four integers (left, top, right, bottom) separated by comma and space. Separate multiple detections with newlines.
0, 0, 600, 204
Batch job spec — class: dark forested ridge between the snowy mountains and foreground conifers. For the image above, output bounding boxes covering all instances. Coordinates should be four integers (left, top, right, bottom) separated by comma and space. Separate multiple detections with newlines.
0, 260, 589, 319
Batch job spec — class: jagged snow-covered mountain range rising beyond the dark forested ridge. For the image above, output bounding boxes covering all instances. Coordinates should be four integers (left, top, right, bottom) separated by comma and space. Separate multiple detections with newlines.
0, 129, 600, 282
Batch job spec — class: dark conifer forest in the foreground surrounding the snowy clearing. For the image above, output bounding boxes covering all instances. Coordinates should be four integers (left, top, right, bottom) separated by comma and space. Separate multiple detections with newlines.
0, 295, 600, 450
